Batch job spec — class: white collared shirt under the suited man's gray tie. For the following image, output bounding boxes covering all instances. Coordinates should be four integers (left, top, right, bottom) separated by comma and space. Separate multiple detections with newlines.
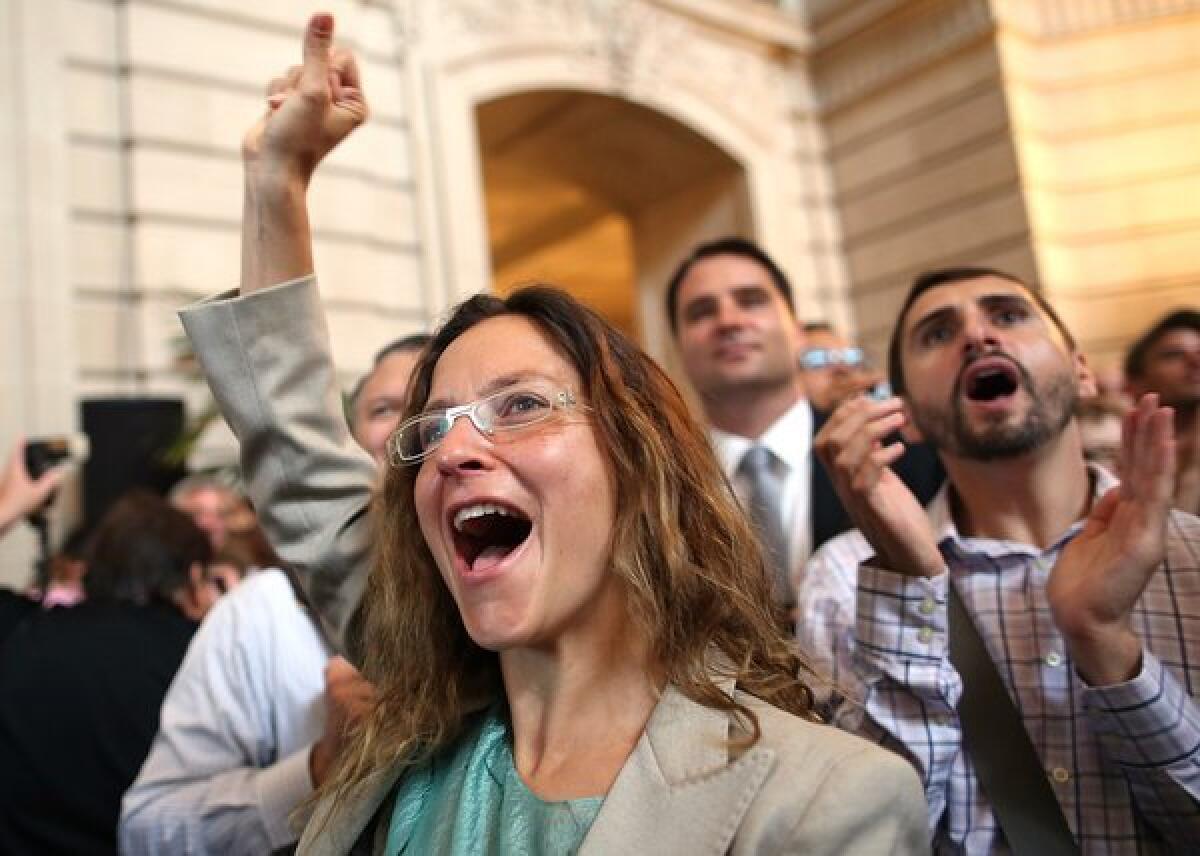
709, 399, 812, 582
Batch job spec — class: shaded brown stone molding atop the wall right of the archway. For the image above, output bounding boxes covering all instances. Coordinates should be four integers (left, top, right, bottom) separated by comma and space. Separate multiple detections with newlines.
811, 0, 995, 112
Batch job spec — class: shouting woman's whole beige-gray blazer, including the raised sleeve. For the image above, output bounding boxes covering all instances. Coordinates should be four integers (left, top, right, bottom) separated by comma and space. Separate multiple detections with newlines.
180, 277, 929, 856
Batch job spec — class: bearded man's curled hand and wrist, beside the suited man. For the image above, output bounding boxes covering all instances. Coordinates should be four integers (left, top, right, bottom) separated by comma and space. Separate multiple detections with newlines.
814, 397, 946, 576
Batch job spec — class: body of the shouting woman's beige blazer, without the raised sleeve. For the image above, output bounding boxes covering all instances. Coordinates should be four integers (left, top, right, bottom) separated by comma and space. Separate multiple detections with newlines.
296, 672, 929, 856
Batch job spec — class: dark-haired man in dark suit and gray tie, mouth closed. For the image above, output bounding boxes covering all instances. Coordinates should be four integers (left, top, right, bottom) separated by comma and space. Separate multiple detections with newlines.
666, 238, 942, 607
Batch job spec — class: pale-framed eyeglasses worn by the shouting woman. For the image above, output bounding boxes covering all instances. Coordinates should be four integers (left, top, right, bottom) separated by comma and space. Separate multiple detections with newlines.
388, 383, 583, 467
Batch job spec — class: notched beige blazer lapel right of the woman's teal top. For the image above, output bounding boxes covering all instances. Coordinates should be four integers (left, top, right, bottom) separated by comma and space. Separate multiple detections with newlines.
580, 684, 775, 856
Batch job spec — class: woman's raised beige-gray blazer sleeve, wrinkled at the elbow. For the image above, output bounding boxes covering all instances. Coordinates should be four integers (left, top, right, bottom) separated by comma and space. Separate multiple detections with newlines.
179, 276, 377, 651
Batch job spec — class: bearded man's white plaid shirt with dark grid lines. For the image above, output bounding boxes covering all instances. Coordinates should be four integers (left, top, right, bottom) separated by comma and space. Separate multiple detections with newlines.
799, 468, 1200, 854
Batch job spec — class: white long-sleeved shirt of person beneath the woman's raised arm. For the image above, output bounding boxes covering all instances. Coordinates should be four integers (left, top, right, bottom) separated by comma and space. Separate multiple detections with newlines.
119, 570, 329, 856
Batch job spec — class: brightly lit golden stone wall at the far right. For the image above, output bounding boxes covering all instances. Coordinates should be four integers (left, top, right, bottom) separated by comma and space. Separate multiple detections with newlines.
998, 0, 1200, 366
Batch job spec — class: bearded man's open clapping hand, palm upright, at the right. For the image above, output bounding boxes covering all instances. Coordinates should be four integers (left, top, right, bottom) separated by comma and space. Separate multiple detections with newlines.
1046, 395, 1175, 686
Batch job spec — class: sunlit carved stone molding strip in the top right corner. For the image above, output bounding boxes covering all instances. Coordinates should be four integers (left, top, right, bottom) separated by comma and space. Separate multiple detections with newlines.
992, 0, 1200, 38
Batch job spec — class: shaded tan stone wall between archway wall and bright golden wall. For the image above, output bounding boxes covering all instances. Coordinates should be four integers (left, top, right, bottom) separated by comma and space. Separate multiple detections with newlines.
812, 0, 1034, 359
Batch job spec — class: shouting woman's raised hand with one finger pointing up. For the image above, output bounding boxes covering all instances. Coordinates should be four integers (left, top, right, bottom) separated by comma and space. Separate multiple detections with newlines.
242, 13, 368, 181
